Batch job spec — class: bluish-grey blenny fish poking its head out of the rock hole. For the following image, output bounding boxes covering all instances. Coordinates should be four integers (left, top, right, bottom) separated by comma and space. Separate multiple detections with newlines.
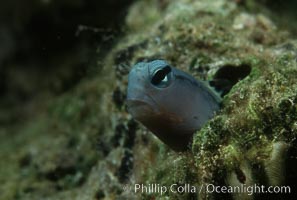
127, 60, 221, 151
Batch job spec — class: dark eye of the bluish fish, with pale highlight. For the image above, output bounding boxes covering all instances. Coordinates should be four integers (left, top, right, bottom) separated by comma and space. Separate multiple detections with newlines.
151, 66, 171, 88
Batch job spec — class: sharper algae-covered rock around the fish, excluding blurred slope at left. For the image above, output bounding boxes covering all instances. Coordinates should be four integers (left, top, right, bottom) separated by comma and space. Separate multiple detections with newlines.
109, 1, 297, 199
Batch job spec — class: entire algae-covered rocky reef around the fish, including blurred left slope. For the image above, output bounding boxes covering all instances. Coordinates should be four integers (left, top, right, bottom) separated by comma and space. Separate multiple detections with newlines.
0, 0, 297, 200
